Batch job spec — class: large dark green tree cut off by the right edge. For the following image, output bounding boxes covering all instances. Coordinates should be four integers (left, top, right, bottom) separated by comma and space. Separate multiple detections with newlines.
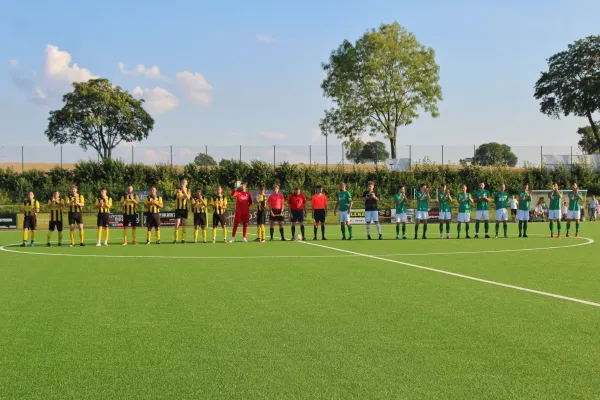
534, 35, 600, 151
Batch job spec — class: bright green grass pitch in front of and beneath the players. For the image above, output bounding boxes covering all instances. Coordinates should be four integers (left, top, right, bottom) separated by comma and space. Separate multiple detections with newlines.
0, 223, 600, 400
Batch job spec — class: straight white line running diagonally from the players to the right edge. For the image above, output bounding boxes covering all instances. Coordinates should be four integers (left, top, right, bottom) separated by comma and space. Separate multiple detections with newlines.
299, 242, 600, 307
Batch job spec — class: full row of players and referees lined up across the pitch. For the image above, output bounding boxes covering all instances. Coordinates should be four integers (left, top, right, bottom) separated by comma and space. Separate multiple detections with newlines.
21, 179, 583, 247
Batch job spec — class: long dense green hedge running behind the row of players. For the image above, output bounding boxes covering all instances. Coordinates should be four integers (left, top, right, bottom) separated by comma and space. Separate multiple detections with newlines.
0, 160, 600, 208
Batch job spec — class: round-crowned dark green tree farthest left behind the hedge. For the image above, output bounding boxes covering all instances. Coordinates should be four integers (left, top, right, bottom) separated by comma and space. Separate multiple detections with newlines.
45, 79, 154, 159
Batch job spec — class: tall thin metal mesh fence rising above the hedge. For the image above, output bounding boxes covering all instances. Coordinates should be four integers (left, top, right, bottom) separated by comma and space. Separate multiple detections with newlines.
0, 145, 582, 170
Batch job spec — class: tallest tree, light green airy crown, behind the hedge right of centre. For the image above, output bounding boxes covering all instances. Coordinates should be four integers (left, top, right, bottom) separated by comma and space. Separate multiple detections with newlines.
321, 22, 442, 158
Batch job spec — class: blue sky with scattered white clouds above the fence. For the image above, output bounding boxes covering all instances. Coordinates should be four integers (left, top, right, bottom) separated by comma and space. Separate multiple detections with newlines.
0, 0, 600, 156
